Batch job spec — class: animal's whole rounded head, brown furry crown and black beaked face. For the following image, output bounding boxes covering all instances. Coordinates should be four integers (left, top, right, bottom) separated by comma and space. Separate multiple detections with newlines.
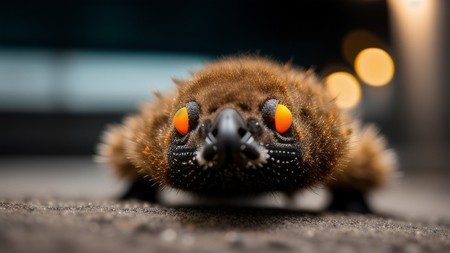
166, 58, 347, 195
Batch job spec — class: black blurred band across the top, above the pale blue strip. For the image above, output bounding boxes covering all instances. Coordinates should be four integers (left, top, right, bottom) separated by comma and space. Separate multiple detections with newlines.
0, 0, 389, 62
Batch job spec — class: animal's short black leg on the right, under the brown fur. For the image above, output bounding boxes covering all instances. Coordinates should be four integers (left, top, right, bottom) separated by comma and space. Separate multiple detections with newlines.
327, 188, 372, 214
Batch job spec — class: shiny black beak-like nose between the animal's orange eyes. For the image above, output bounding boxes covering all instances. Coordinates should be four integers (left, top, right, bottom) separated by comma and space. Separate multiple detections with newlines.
203, 108, 260, 163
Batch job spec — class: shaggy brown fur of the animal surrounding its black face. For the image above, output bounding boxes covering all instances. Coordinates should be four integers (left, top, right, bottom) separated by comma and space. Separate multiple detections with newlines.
99, 57, 395, 199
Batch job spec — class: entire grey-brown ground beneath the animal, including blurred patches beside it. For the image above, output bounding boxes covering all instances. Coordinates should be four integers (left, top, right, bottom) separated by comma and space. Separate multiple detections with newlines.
0, 158, 450, 253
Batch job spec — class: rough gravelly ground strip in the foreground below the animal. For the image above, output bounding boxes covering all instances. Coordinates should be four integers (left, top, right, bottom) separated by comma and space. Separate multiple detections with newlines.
0, 198, 450, 253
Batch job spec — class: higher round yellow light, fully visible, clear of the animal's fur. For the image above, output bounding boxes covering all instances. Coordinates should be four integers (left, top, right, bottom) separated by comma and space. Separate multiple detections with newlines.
355, 48, 394, 86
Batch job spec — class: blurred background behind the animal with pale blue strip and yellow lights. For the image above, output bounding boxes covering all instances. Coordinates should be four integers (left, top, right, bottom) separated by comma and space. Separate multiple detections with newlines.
0, 0, 450, 217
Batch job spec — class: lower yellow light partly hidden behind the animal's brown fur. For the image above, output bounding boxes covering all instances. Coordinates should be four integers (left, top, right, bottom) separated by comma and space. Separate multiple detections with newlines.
325, 72, 361, 109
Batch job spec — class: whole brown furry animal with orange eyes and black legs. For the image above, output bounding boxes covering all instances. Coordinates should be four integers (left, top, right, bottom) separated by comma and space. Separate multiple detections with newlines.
99, 56, 395, 212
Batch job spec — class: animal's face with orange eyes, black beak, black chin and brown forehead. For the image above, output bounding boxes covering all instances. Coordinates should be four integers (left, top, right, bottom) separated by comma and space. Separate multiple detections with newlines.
167, 80, 310, 195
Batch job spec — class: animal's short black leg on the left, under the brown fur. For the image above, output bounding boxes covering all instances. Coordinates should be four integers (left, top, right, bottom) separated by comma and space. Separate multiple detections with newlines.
120, 179, 159, 203
